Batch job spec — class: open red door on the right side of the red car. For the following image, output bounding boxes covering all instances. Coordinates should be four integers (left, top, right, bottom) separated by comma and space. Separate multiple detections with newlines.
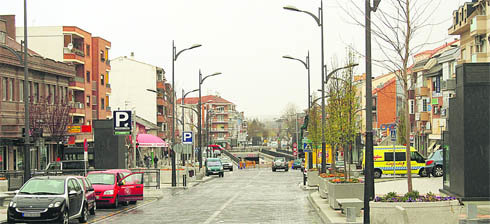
118, 173, 143, 201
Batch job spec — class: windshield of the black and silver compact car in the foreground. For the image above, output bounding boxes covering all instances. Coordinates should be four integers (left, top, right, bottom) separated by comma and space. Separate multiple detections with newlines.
19, 179, 65, 194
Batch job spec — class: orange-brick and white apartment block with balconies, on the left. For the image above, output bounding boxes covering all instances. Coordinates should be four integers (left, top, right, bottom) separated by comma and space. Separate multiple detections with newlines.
16, 26, 111, 146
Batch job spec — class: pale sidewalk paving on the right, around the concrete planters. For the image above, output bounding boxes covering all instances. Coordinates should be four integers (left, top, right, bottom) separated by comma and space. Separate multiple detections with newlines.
301, 178, 490, 223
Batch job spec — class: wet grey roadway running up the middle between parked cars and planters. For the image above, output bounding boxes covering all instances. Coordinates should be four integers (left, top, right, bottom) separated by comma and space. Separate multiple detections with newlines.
92, 168, 322, 224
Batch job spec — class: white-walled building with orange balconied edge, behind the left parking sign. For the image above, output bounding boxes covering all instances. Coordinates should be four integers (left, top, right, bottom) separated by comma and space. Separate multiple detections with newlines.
109, 53, 172, 140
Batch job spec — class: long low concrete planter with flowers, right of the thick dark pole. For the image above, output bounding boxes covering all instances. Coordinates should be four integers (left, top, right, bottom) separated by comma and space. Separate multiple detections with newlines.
369, 200, 463, 223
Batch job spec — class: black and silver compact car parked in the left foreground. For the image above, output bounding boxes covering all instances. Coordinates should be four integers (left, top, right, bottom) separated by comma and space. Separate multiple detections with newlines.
7, 176, 88, 223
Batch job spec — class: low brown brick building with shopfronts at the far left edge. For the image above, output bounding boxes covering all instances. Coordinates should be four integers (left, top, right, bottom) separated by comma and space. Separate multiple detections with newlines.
0, 15, 76, 170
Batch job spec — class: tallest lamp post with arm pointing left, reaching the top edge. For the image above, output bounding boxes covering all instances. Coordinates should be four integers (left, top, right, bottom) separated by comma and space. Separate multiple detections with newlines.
283, 0, 327, 173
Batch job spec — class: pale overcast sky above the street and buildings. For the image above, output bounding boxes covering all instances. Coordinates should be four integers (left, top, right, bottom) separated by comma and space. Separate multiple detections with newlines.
0, 0, 465, 119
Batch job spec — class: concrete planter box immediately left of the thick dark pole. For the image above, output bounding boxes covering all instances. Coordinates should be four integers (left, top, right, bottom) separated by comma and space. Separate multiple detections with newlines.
327, 182, 364, 209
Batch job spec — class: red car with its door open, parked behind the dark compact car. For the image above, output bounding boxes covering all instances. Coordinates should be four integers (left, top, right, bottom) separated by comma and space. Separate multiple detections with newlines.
87, 170, 143, 208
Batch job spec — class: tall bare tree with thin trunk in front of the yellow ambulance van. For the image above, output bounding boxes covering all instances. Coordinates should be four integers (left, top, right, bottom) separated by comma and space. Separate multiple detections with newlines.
344, 0, 441, 192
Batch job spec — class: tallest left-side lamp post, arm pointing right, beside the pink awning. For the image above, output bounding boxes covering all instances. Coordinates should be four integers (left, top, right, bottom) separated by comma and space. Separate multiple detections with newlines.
170, 41, 202, 187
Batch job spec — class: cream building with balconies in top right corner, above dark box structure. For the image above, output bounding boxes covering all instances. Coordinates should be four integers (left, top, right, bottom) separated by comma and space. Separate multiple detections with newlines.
448, 0, 490, 64
